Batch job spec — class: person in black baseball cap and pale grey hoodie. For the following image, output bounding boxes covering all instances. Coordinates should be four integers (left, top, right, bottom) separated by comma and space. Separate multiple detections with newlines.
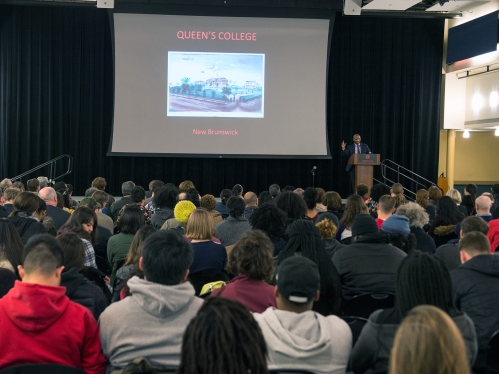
253, 256, 352, 374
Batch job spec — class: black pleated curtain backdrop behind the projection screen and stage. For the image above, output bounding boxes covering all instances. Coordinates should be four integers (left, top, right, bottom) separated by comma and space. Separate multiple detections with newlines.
0, 5, 444, 195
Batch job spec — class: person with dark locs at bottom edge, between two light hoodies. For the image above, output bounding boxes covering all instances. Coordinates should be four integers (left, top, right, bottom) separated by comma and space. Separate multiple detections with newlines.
177, 297, 268, 374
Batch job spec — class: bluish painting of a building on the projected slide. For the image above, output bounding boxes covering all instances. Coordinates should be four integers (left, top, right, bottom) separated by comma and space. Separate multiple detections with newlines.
167, 52, 265, 118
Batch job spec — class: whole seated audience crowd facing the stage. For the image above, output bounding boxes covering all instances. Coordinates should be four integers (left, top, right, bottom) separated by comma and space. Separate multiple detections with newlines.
0, 177, 499, 374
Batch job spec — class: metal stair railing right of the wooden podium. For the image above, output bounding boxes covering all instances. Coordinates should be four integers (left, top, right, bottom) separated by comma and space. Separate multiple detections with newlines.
377, 159, 440, 201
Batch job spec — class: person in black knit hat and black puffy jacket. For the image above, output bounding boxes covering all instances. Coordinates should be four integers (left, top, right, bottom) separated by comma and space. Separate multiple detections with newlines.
333, 213, 407, 300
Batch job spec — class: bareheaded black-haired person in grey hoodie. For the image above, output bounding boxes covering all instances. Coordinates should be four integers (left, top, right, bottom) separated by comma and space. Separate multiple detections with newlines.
99, 230, 203, 369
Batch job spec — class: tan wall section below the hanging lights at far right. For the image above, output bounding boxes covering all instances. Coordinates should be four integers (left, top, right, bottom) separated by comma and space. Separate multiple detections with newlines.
438, 131, 499, 184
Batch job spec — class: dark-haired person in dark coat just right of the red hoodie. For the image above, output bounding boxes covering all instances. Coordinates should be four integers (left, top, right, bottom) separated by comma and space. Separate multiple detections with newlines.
57, 234, 109, 320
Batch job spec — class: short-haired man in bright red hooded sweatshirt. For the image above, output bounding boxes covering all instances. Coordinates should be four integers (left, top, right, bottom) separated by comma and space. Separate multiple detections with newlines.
0, 234, 107, 374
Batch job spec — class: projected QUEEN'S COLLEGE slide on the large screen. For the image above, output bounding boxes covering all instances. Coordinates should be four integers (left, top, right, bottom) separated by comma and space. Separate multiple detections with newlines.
108, 13, 329, 157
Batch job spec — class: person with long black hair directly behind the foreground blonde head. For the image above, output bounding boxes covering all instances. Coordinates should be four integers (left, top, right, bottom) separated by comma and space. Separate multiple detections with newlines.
350, 251, 477, 374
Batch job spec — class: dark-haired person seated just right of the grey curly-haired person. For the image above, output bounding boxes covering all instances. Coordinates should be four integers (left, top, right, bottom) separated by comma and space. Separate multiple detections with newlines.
428, 196, 464, 247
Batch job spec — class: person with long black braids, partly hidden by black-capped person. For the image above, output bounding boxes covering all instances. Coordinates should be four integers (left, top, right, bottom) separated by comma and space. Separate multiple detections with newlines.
278, 219, 341, 316
